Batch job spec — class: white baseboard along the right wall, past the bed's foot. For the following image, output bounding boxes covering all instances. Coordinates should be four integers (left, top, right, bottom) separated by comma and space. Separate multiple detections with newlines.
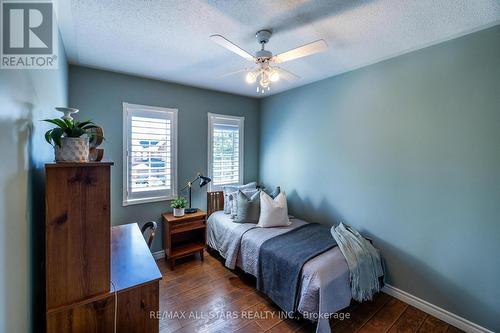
382, 284, 493, 333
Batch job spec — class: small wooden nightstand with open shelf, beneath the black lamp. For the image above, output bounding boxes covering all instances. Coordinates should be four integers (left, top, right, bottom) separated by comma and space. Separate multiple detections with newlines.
162, 209, 207, 270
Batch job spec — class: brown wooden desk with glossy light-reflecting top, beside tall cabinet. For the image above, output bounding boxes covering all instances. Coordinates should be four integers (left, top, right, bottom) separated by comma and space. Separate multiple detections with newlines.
47, 223, 162, 333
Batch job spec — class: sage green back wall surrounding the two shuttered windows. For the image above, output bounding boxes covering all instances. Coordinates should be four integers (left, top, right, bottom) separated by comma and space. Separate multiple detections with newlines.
69, 65, 259, 251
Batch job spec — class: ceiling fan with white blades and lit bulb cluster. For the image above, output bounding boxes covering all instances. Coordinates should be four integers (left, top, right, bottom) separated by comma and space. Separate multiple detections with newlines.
210, 30, 328, 93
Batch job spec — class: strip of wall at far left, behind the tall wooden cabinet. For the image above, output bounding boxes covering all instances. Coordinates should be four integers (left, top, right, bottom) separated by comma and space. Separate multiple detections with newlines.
0, 37, 68, 333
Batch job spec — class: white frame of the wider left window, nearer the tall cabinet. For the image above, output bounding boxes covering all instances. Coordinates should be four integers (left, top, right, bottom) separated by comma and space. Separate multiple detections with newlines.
122, 102, 179, 206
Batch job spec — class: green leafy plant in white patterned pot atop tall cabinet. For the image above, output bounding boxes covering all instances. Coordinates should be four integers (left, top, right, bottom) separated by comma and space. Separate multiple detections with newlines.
44, 118, 97, 162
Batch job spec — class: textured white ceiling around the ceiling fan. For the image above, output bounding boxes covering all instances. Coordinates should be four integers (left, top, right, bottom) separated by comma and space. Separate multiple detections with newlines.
57, 0, 500, 97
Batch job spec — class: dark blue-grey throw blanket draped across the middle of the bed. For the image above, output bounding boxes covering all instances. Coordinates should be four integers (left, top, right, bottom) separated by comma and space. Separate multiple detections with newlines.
257, 223, 337, 312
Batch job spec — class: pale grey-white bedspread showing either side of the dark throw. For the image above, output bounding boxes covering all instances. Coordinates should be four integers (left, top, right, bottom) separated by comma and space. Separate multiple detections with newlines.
208, 211, 351, 332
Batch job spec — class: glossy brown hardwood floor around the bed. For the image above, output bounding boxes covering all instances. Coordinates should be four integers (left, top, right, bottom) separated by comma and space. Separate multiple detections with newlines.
157, 250, 461, 333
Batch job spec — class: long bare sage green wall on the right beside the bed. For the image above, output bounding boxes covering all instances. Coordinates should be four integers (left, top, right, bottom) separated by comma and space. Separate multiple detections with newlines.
259, 26, 500, 332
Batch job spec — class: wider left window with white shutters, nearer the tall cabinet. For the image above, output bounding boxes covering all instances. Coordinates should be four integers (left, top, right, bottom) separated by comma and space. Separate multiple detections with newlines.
123, 103, 177, 206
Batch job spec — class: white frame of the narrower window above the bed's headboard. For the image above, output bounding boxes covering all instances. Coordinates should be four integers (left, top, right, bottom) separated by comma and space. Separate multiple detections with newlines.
207, 112, 245, 191
